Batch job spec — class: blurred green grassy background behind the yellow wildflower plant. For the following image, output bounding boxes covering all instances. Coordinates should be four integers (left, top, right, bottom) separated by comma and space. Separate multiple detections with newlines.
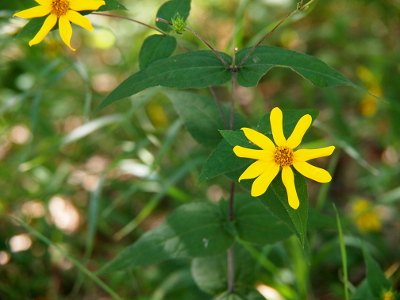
0, 0, 400, 300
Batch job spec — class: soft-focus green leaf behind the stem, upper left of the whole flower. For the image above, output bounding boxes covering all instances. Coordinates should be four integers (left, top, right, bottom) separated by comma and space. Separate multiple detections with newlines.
163, 90, 249, 148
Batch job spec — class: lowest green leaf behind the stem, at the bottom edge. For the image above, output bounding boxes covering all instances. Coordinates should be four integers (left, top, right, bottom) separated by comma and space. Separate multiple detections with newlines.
191, 243, 256, 295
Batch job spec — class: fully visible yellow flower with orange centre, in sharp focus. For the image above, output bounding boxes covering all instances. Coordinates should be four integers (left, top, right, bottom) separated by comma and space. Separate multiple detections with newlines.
233, 107, 335, 209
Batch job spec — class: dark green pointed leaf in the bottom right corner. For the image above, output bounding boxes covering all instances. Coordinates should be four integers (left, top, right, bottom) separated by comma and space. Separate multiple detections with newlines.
363, 247, 391, 299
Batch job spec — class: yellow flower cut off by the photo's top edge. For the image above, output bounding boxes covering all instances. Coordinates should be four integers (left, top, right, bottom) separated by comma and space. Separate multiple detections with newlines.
14, 0, 106, 51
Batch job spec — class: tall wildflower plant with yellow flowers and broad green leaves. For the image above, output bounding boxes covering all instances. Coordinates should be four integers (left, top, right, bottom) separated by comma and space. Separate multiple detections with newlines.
6, 0, 396, 300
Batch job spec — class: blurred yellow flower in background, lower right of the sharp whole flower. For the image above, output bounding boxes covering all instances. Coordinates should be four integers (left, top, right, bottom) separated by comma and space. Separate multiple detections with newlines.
352, 198, 382, 232
